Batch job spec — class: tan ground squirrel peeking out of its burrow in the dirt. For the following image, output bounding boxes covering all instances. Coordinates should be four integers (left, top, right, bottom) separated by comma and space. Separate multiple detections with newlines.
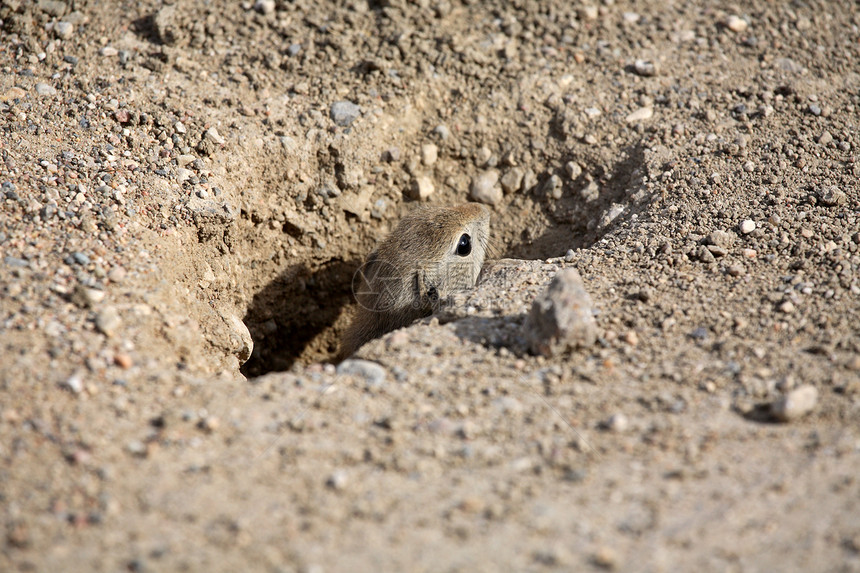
339, 203, 490, 359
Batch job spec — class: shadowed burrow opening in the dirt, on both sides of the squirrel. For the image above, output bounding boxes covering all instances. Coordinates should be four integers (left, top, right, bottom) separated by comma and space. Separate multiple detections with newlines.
241, 147, 647, 378
